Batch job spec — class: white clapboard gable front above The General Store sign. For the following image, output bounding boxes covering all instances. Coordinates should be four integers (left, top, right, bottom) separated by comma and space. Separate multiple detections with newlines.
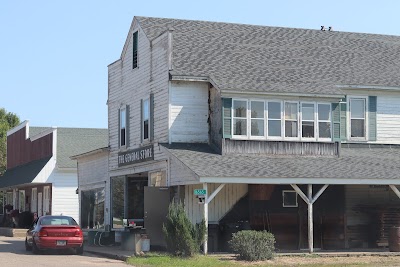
107, 22, 169, 171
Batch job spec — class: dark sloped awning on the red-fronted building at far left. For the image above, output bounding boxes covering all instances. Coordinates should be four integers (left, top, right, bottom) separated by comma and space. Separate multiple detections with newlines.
0, 157, 51, 188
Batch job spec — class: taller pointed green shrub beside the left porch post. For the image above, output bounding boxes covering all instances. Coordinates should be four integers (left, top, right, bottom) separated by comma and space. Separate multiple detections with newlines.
163, 203, 206, 257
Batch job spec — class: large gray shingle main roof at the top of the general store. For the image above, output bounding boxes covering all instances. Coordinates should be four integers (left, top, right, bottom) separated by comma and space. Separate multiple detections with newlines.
135, 17, 400, 95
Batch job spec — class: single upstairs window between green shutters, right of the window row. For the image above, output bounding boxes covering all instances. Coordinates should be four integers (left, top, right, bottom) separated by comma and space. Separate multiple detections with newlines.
347, 96, 368, 141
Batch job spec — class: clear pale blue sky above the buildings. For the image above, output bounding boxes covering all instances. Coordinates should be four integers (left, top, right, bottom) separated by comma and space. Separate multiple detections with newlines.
0, 0, 400, 128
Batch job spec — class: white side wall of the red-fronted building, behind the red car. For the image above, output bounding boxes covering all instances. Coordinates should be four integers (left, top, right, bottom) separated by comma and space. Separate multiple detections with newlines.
49, 170, 79, 224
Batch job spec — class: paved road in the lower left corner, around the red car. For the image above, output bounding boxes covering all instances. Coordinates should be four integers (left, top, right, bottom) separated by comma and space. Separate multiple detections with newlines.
0, 236, 129, 267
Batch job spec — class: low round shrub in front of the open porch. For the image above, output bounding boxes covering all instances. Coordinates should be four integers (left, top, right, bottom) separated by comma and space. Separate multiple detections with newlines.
229, 230, 275, 261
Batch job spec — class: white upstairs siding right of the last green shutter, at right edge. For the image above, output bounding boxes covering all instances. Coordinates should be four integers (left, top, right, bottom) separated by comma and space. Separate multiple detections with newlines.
376, 96, 400, 144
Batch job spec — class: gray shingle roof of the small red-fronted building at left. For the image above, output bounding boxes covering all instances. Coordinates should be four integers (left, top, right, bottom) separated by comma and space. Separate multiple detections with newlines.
29, 127, 108, 168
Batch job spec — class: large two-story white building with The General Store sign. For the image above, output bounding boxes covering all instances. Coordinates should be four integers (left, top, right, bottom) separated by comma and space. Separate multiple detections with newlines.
101, 17, 400, 251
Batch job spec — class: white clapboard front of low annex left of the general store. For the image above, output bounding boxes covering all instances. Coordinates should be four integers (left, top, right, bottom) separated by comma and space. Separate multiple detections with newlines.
78, 152, 111, 228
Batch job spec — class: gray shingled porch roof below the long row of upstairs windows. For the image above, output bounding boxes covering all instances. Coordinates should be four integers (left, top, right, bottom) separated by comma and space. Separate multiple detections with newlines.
162, 144, 400, 185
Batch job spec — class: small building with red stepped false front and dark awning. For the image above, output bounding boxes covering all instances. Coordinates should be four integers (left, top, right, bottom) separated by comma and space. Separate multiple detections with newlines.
0, 121, 108, 226
